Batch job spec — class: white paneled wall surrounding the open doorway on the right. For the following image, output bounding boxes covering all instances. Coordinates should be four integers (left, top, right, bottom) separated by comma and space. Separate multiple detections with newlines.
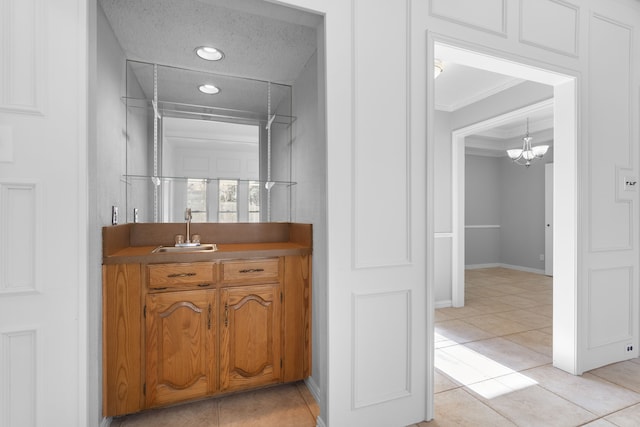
284, 0, 640, 426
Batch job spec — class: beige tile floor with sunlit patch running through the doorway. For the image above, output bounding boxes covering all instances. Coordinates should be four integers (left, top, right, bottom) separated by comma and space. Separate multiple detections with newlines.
416, 268, 640, 427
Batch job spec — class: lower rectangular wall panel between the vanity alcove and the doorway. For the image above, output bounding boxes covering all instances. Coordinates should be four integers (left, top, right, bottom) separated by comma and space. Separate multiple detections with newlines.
351, 290, 412, 409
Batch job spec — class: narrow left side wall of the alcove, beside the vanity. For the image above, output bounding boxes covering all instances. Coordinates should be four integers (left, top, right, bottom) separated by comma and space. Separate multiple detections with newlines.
92, 4, 126, 425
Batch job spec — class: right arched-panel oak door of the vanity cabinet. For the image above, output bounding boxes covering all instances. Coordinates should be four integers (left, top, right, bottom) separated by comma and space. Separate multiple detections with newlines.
220, 284, 281, 391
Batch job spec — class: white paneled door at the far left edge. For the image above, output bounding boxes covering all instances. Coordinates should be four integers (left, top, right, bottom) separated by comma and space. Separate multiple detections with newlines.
0, 0, 87, 427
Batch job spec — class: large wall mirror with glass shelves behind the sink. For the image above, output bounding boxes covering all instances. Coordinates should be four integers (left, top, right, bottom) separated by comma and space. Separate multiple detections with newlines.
123, 61, 295, 226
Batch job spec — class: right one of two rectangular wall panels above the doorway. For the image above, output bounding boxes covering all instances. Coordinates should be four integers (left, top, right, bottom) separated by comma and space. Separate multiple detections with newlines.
519, 0, 580, 58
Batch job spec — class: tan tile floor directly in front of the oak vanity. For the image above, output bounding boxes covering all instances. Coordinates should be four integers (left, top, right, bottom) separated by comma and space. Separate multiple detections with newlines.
111, 382, 320, 427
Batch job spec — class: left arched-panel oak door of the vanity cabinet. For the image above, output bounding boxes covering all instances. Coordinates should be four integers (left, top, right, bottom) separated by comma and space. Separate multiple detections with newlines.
146, 291, 216, 407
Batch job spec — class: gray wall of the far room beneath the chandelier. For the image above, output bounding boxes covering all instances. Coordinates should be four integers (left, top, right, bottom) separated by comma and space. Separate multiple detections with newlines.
465, 149, 553, 270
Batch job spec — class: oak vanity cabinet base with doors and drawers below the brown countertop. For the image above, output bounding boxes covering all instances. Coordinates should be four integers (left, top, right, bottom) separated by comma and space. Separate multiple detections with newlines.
103, 255, 311, 416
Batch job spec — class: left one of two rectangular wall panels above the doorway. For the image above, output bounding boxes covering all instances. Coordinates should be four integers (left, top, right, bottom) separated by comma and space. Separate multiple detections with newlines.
429, 0, 507, 37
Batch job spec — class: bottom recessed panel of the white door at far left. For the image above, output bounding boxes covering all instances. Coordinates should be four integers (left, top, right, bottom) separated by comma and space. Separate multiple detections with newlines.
0, 329, 38, 427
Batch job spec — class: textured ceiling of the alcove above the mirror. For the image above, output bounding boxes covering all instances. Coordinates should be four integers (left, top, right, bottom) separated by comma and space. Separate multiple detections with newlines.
100, 0, 322, 84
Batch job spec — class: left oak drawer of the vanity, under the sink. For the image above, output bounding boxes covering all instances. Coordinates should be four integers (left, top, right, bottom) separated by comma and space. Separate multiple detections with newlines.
147, 262, 216, 290
